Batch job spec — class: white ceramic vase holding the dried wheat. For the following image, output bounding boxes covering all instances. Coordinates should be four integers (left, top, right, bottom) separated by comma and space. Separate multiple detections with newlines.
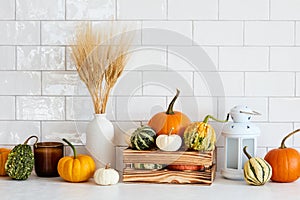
86, 114, 115, 168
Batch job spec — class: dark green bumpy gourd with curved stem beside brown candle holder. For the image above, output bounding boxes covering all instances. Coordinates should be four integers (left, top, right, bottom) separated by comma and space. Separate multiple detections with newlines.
5, 135, 38, 180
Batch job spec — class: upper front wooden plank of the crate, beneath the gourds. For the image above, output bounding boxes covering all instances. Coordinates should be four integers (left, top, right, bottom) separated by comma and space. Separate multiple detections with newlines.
123, 149, 214, 166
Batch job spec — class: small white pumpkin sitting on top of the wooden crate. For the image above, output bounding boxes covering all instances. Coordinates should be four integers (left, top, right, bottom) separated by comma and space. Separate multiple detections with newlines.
156, 127, 182, 151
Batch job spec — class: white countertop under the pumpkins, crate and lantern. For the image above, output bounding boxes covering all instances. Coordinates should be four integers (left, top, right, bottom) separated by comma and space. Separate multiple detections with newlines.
0, 175, 300, 200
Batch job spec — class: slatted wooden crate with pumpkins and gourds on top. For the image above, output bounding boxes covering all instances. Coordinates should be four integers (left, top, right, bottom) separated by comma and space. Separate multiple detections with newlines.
123, 149, 216, 185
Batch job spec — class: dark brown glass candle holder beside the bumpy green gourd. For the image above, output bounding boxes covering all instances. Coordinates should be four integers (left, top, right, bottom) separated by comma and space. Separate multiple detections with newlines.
33, 142, 64, 177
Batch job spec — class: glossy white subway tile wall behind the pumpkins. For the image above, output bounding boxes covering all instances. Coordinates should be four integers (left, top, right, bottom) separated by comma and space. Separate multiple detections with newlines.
0, 0, 300, 169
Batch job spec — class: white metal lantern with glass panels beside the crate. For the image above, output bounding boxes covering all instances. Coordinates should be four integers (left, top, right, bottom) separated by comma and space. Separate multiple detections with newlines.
221, 105, 260, 179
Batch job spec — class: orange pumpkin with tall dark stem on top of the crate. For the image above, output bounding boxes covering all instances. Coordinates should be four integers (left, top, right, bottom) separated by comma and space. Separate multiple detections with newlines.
148, 89, 191, 136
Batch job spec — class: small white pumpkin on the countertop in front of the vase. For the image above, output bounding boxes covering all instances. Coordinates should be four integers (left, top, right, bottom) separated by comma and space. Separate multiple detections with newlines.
94, 164, 119, 185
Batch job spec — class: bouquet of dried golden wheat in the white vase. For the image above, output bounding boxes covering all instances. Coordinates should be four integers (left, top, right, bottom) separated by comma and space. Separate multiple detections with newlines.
71, 23, 133, 114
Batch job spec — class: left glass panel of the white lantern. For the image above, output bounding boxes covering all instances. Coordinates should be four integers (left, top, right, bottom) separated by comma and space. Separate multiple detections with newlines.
226, 138, 239, 169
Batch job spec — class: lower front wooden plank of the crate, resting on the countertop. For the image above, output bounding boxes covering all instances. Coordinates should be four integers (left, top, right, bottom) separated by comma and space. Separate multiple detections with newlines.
123, 166, 215, 185
